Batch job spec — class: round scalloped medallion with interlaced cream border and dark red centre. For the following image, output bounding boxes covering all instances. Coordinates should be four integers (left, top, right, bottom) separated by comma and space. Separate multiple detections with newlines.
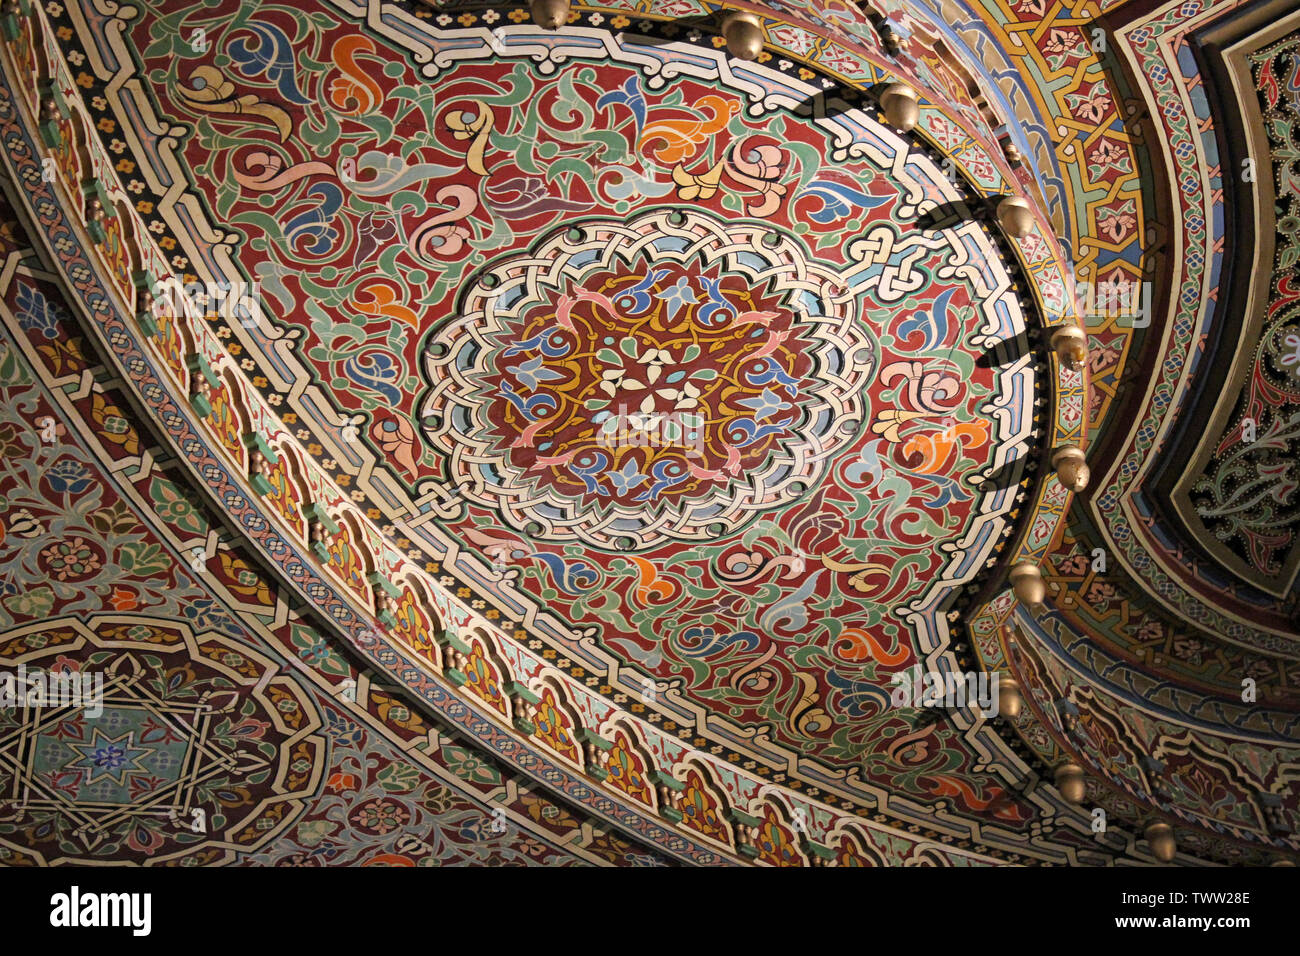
423, 209, 876, 549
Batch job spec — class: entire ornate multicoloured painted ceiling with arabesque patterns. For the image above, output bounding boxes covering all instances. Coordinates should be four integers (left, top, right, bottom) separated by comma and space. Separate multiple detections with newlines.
0, 0, 1300, 866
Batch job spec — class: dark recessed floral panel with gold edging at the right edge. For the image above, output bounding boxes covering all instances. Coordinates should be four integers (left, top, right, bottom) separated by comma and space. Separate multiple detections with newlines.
1173, 10, 1300, 606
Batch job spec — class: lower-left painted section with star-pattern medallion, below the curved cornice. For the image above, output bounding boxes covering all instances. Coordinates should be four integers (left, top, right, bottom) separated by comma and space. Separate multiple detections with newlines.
0, 209, 722, 865
